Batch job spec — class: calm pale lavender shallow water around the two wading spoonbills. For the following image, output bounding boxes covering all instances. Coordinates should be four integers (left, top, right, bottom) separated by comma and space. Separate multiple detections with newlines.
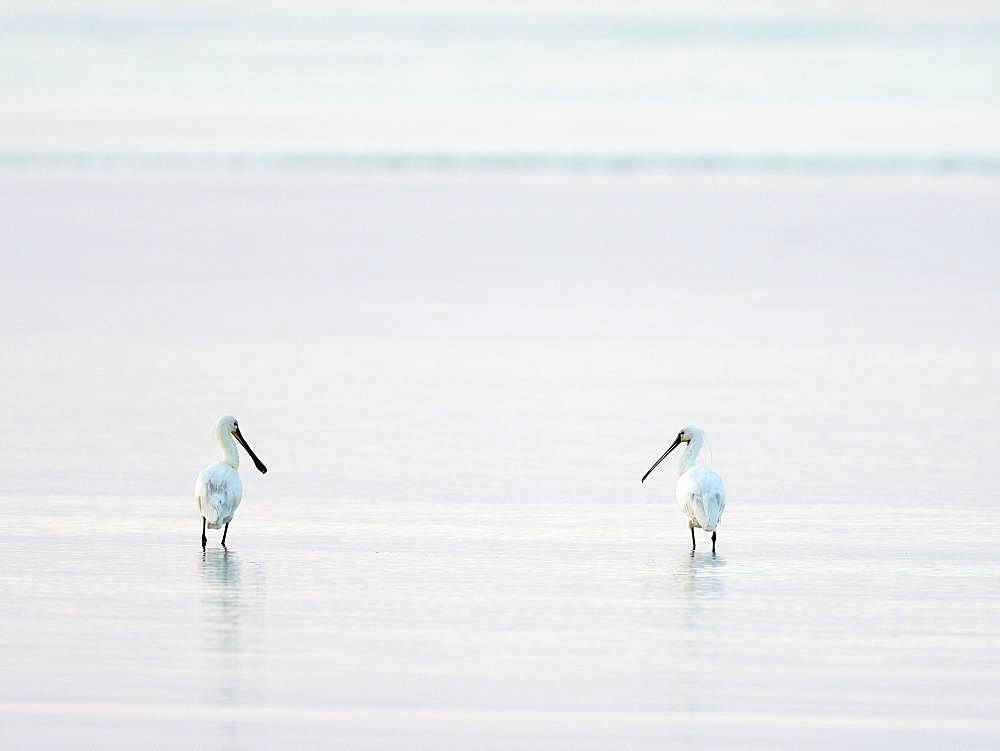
0, 177, 1000, 749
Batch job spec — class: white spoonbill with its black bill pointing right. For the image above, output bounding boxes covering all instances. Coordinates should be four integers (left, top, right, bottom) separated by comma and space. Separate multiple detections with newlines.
194, 415, 267, 548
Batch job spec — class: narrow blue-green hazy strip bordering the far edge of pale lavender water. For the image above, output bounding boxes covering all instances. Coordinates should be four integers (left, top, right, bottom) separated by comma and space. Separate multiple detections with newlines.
0, 149, 1000, 177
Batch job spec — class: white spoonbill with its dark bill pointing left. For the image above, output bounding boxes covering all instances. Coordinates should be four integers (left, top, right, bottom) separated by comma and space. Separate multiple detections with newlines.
642, 425, 726, 553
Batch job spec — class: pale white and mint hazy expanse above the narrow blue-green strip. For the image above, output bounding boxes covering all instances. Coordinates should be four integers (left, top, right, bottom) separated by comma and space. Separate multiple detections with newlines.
0, 0, 1000, 158
